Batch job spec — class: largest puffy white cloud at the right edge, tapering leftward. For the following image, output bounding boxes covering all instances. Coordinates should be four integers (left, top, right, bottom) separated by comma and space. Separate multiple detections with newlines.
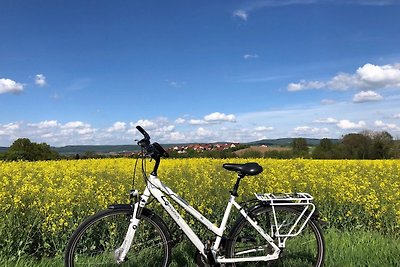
287, 63, 400, 92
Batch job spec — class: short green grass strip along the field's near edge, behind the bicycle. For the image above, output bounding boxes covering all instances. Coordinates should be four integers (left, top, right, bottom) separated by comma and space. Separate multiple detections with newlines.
0, 229, 400, 267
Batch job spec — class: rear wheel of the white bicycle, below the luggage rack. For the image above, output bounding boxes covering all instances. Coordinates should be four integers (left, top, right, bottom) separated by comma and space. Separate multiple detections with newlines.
225, 205, 325, 267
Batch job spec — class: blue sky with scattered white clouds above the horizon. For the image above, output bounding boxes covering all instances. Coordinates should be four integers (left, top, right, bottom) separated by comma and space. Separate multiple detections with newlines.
0, 0, 400, 146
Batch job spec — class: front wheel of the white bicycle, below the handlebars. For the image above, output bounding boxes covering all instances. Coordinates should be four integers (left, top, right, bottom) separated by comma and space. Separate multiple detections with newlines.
65, 207, 172, 267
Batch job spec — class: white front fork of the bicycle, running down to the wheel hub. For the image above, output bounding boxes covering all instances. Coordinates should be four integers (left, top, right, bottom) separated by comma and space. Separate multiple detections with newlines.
114, 188, 150, 264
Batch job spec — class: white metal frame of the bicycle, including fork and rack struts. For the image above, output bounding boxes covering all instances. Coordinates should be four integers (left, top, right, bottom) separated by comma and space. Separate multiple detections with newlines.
115, 175, 315, 263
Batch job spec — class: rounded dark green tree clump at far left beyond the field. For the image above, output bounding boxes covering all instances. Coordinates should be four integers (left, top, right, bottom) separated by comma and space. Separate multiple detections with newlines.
5, 138, 59, 161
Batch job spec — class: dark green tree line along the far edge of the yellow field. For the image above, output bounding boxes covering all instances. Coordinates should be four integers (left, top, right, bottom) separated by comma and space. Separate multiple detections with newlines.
0, 131, 400, 161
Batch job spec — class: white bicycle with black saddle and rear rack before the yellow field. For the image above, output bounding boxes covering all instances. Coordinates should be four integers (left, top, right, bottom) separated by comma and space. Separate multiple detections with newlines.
65, 126, 325, 267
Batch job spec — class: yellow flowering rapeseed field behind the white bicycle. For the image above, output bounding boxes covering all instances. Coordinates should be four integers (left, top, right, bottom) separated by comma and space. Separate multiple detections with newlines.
0, 158, 400, 256
